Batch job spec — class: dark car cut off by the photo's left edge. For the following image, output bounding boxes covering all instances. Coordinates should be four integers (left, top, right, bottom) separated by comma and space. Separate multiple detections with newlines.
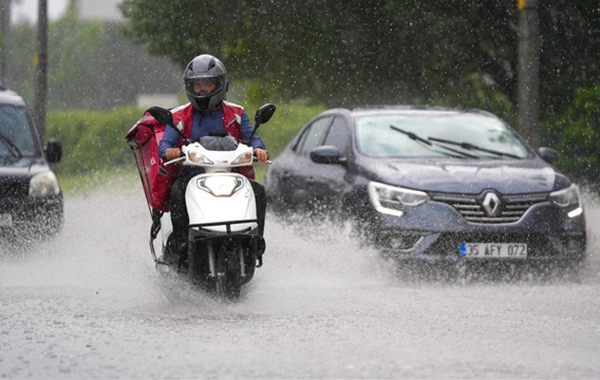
0, 87, 63, 241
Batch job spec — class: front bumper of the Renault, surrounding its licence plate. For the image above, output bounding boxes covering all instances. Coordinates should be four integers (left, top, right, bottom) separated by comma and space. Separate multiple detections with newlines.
370, 202, 586, 262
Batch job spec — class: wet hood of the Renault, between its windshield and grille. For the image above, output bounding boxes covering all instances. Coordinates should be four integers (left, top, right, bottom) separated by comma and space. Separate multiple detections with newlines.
368, 159, 568, 194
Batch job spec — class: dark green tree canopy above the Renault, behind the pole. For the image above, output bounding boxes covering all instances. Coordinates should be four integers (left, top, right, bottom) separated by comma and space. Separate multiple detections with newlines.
122, 0, 600, 116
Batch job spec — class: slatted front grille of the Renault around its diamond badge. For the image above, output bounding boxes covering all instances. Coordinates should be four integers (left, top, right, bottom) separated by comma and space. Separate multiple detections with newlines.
431, 193, 548, 224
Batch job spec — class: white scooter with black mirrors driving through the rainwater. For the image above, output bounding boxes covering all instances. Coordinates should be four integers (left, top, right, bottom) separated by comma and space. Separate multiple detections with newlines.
148, 104, 275, 300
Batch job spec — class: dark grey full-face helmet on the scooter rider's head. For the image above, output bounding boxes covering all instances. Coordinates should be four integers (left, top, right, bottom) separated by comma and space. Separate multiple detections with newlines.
183, 54, 229, 112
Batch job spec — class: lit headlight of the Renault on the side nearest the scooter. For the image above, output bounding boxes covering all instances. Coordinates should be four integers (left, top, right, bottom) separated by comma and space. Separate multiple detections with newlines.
368, 182, 429, 216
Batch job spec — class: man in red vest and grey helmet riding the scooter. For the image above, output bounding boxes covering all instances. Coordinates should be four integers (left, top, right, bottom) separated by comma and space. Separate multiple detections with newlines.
158, 54, 269, 261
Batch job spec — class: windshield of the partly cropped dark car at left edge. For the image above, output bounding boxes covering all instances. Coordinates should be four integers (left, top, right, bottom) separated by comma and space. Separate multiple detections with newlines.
0, 105, 35, 158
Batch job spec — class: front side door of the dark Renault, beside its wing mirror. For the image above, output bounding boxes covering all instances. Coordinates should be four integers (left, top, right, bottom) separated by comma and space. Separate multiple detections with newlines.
306, 115, 351, 213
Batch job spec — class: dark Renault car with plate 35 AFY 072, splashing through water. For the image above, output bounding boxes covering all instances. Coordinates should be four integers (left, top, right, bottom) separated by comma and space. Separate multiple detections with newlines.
265, 106, 586, 263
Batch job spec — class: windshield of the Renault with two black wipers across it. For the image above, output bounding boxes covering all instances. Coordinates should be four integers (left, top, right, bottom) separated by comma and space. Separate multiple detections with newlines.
356, 112, 529, 158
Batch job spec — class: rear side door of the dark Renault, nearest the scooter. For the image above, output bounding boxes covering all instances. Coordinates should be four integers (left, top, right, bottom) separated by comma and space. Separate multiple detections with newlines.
278, 116, 333, 211
